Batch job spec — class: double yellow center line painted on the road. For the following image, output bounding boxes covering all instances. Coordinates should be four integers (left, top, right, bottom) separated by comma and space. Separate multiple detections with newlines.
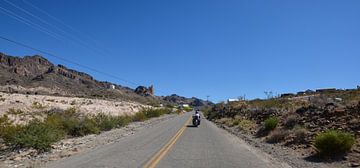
143, 117, 191, 168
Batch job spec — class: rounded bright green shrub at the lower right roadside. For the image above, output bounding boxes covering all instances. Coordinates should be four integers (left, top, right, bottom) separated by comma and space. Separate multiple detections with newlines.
314, 130, 355, 156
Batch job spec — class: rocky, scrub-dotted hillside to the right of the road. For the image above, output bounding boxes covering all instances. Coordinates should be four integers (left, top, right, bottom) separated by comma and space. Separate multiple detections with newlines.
207, 87, 360, 166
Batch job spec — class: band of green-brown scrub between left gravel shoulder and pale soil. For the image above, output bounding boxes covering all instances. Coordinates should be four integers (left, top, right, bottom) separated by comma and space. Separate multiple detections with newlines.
0, 108, 172, 152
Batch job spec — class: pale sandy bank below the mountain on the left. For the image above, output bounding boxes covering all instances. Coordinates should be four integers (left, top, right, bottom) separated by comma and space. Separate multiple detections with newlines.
0, 92, 150, 116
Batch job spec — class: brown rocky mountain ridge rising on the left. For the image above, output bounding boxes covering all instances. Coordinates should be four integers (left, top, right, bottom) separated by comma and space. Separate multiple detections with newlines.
0, 53, 211, 105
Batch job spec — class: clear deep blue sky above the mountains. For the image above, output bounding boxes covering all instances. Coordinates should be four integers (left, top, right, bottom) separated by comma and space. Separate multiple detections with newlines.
0, 0, 360, 101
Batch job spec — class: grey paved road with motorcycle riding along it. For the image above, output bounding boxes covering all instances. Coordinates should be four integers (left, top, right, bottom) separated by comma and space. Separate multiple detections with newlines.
47, 113, 286, 168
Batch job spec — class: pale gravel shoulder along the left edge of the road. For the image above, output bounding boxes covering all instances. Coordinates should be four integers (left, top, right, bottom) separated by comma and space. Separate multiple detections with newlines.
0, 114, 177, 167
